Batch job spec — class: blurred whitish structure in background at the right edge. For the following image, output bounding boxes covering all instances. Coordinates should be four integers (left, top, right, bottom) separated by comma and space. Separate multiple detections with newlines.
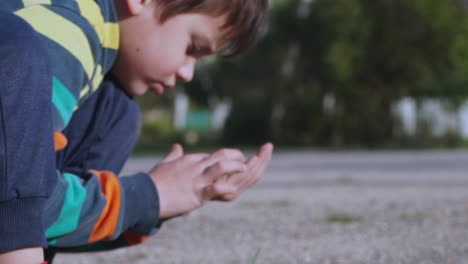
393, 97, 468, 139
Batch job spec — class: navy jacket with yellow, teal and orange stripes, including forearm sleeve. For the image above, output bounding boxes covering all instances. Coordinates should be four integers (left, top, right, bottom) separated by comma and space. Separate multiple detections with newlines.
0, 0, 159, 250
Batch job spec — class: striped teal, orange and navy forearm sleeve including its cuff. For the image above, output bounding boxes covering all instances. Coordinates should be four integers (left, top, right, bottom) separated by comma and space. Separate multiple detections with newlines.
45, 171, 159, 250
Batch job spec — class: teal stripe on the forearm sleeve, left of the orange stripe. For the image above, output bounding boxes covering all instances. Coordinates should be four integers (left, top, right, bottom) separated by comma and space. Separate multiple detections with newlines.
46, 173, 86, 239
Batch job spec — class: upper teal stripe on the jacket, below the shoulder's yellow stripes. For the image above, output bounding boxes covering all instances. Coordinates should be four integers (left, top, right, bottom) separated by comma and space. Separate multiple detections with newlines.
52, 76, 77, 125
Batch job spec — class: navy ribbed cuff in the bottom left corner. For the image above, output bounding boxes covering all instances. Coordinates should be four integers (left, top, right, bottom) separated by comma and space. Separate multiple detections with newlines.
0, 197, 47, 253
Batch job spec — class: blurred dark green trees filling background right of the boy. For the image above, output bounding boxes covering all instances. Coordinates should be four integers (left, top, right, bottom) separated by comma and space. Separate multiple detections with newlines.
198, 0, 468, 147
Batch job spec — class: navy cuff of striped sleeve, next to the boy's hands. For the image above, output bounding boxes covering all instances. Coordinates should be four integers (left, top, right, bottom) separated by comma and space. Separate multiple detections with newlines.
120, 173, 161, 235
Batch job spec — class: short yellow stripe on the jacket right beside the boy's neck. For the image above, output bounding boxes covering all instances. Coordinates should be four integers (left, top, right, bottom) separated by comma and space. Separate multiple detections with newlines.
77, 0, 119, 49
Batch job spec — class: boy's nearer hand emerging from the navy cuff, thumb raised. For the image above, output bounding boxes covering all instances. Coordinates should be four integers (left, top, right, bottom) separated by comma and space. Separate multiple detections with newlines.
149, 145, 247, 219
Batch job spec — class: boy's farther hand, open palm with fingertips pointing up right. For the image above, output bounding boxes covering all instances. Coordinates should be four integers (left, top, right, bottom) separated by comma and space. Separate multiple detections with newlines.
209, 143, 273, 201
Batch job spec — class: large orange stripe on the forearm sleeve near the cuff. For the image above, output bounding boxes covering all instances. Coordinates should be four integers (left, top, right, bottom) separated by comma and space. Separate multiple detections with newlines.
88, 170, 121, 243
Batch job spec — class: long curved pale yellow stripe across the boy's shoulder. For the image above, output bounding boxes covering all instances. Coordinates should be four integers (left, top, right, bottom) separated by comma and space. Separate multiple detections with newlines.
16, 5, 95, 78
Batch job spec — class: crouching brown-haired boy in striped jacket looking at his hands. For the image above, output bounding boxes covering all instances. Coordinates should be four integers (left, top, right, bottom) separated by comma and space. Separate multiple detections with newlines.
0, 0, 272, 263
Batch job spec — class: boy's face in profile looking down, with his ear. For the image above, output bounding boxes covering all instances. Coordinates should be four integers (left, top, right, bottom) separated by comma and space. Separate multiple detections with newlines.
112, 1, 224, 96
